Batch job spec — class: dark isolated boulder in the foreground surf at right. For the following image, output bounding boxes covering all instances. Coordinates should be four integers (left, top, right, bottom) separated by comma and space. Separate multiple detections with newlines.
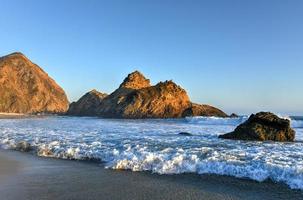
219, 112, 295, 142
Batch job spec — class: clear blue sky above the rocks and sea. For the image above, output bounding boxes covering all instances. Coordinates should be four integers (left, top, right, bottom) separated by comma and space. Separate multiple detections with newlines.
0, 0, 303, 115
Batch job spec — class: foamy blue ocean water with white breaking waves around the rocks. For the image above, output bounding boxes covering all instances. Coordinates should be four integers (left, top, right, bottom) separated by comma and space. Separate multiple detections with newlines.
0, 117, 303, 190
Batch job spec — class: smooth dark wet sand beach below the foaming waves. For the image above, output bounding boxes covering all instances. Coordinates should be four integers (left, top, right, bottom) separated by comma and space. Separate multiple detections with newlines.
0, 150, 303, 200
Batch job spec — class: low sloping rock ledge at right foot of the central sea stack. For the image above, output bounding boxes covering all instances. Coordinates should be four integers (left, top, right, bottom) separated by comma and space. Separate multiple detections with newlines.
182, 103, 227, 117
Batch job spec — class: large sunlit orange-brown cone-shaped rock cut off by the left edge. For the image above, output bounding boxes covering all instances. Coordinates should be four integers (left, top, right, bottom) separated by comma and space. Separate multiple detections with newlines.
0, 53, 69, 114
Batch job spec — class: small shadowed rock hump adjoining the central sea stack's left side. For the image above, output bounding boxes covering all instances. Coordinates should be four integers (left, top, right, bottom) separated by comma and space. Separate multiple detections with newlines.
67, 90, 107, 116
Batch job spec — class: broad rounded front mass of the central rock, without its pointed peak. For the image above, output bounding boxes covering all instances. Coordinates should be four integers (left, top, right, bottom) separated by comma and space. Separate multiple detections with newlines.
98, 78, 190, 118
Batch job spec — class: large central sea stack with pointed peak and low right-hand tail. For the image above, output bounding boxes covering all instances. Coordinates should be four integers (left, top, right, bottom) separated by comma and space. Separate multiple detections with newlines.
68, 71, 227, 119
